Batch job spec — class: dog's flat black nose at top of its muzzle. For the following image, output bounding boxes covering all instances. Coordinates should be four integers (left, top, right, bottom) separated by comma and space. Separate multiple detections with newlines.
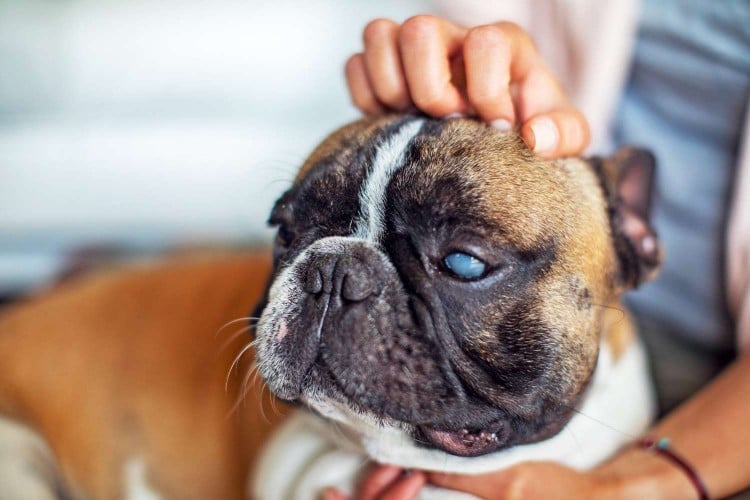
305, 254, 379, 302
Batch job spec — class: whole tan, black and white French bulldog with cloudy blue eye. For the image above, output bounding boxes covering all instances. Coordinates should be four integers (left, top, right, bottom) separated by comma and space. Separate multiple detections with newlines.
0, 115, 661, 500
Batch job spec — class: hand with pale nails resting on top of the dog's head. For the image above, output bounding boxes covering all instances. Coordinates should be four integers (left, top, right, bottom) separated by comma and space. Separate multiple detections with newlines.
346, 15, 589, 158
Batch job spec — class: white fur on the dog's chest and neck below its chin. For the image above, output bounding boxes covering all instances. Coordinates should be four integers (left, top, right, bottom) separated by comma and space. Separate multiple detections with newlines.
250, 342, 655, 500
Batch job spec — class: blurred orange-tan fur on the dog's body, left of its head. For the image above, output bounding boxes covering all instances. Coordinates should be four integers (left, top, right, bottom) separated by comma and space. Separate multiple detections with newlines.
0, 251, 290, 499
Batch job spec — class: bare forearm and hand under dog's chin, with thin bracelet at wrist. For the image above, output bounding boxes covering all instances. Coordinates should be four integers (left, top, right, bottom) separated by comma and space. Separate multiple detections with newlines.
334, 353, 750, 500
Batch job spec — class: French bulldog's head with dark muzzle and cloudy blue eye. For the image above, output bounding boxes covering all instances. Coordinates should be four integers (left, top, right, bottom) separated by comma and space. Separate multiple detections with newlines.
256, 116, 658, 456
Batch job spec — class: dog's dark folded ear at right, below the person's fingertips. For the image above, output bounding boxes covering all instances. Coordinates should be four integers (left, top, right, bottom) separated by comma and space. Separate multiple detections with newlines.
589, 147, 662, 291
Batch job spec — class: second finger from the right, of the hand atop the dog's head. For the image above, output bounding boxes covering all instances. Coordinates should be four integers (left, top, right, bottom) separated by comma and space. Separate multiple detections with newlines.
463, 25, 515, 131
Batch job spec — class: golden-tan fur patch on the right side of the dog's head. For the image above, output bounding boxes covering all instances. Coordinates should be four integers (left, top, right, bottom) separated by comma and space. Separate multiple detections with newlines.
388, 120, 634, 368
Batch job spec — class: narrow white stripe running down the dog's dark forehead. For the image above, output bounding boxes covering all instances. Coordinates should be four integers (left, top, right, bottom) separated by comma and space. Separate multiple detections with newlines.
353, 118, 424, 243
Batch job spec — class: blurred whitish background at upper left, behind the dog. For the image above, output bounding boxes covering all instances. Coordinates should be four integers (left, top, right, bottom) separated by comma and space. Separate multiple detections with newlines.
0, 0, 432, 297
